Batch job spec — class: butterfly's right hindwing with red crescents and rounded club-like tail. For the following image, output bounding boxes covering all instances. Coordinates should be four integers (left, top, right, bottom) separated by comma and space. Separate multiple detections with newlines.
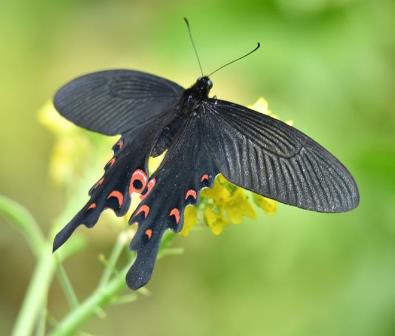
126, 116, 218, 289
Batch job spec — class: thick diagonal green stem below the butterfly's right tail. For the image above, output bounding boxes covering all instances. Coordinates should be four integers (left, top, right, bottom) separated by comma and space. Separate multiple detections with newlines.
51, 265, 129, 336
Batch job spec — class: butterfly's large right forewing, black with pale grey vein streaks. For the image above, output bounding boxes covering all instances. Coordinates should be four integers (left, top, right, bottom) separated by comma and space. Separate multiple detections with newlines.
203, 99, 359, 212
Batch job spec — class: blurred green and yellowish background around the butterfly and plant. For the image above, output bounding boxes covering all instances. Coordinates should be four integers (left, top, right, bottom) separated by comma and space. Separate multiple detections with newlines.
0, 0, 395, 336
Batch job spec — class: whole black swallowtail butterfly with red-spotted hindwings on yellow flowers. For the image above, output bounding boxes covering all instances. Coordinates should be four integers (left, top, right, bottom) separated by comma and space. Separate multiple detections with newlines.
54, 19, 359, 289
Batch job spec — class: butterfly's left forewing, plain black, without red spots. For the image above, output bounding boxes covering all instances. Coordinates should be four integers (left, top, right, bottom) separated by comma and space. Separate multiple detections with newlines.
54, 70, 184, 135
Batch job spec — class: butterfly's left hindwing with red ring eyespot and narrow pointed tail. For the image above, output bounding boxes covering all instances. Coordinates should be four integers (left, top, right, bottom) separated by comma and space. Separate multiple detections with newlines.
53, 115, 172, 250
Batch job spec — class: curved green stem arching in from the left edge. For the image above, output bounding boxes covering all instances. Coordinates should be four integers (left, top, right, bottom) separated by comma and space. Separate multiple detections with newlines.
0, 195, 45, 258
